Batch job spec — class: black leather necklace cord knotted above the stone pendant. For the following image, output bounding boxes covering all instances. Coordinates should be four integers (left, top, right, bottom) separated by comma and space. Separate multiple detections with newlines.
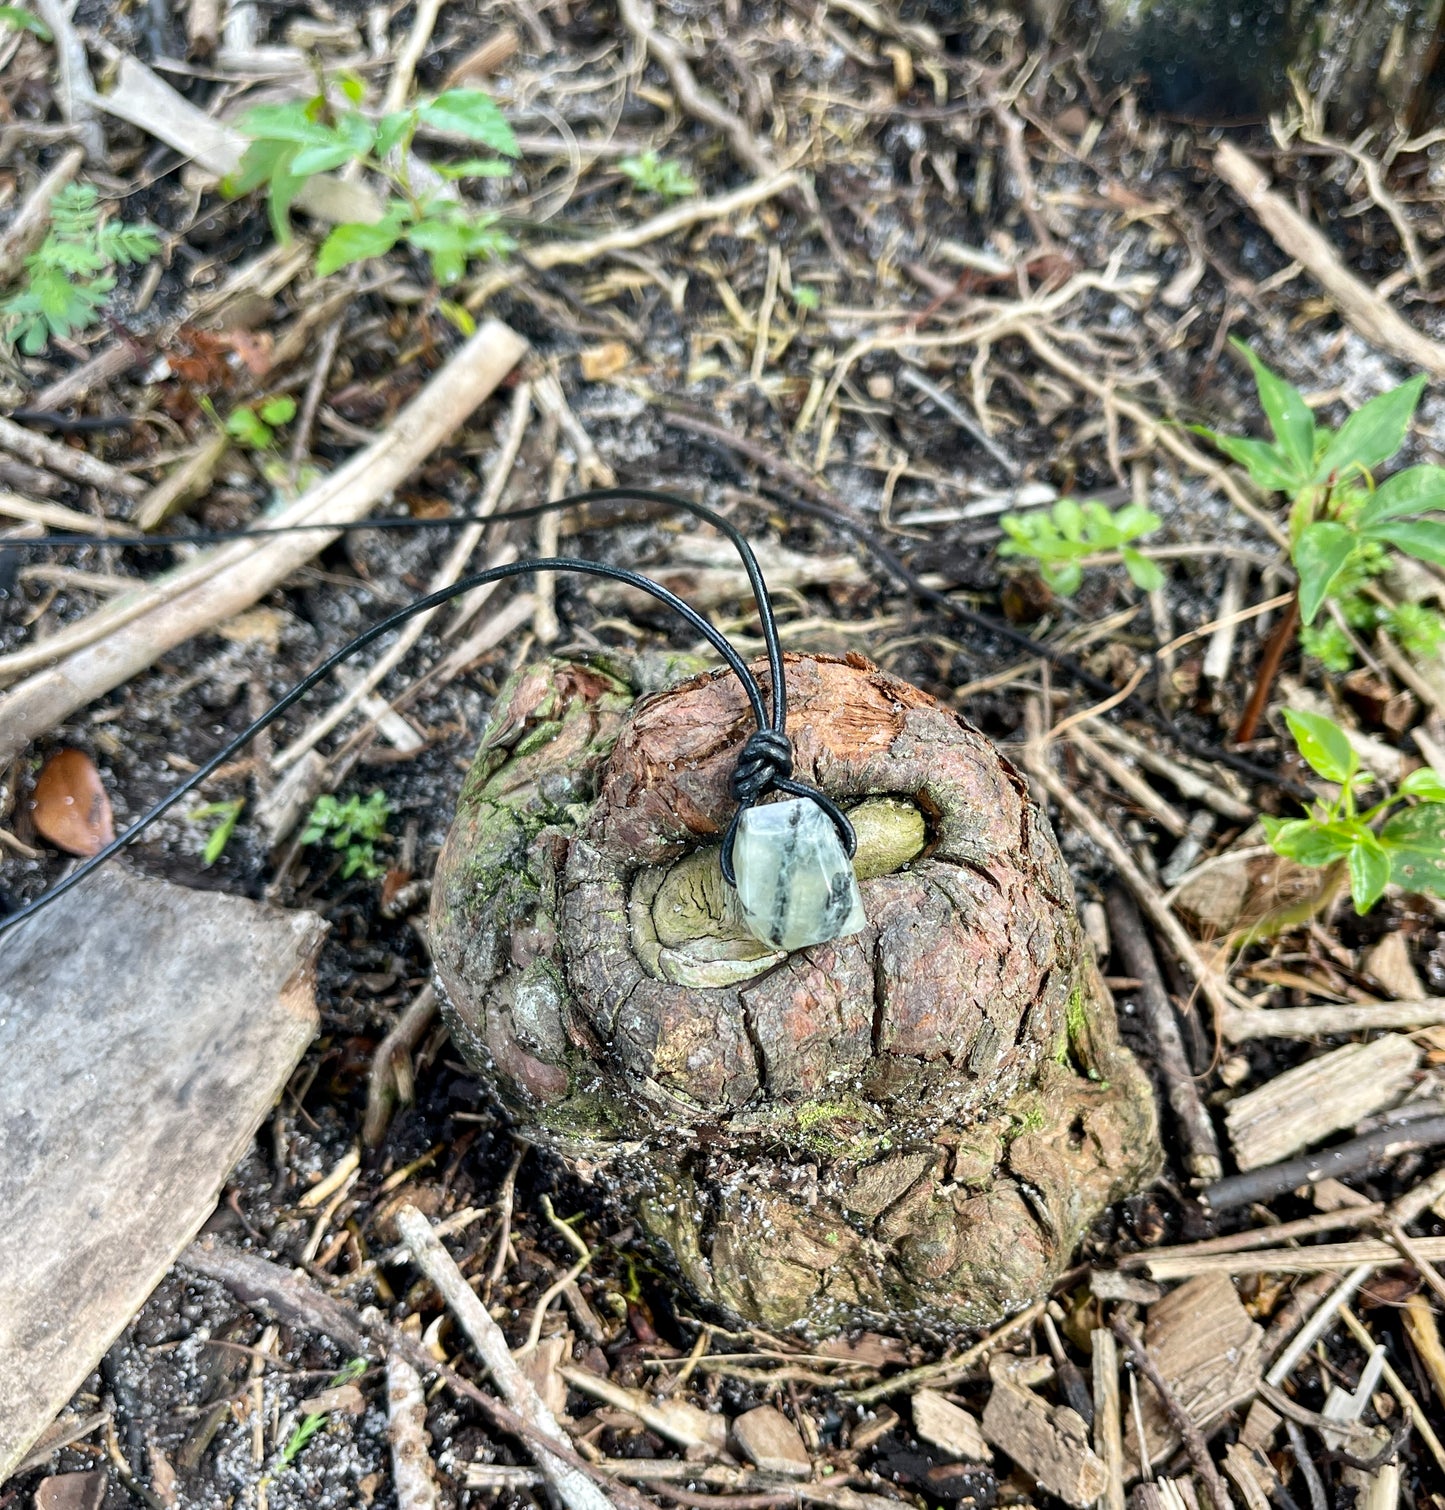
0, 488, 858, 933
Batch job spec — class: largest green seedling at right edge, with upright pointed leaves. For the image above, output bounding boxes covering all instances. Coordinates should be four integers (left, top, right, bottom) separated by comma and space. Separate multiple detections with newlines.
1193, 341, 1445, 670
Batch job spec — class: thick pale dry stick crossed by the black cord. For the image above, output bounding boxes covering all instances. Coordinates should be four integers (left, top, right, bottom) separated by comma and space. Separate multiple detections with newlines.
0, 320, 525, 761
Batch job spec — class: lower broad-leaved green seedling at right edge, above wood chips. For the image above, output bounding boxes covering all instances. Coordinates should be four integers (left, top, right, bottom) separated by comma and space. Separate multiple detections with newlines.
1259, 708, 1445, 914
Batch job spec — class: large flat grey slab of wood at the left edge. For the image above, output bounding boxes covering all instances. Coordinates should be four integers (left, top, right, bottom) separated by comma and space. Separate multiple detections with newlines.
0, 865, 326, 1480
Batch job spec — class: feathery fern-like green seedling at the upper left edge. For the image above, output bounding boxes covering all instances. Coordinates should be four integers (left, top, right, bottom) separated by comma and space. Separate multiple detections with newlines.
0, 184, 160, 356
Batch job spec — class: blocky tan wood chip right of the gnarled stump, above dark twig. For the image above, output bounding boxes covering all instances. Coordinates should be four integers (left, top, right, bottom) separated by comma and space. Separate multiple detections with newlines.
1225, 1033, 1421, 1169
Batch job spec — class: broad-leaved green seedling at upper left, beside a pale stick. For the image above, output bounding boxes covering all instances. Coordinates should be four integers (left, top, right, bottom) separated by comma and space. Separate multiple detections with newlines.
222, 77, 518, 287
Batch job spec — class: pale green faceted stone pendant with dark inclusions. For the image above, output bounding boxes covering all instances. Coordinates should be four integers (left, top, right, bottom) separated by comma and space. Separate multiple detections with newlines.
732, 797, 868, 950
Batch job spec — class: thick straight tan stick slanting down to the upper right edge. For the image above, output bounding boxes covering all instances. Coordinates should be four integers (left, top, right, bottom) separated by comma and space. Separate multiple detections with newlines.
1214, 142, 1445, 378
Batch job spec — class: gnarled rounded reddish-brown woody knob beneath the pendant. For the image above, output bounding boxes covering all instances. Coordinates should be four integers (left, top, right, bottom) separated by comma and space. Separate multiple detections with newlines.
432, 657, 1158, 1332
